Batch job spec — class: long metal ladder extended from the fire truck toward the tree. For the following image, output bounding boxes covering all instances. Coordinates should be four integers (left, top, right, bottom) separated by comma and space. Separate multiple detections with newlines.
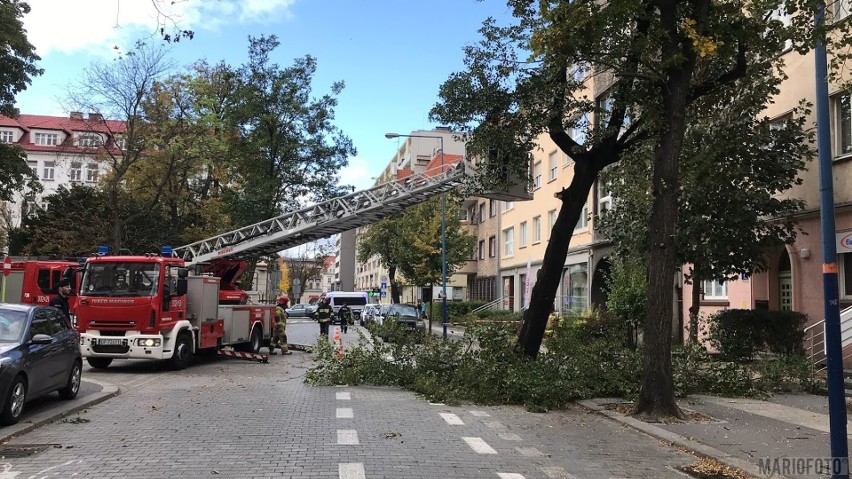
173, 161, 469, 266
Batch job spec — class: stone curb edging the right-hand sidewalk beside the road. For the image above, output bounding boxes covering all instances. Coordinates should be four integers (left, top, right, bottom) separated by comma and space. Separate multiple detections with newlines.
576, 399, 790, 479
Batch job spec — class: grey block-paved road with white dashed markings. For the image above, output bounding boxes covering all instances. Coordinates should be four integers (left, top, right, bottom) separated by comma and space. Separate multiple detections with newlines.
0, 320, 695, 479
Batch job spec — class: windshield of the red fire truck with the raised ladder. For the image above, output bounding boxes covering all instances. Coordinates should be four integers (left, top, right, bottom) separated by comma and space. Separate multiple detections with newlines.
80, 262, 159, 296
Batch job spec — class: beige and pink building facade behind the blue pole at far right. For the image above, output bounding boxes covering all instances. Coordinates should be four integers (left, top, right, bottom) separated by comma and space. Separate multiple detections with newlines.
683, 8, 852, 340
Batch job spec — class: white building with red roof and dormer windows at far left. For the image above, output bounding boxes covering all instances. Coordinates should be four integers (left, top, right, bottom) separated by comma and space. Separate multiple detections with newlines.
0, 112, 126, 227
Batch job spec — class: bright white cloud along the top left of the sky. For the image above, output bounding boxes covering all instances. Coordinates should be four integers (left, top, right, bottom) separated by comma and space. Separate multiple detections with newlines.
24, 0, 296, 57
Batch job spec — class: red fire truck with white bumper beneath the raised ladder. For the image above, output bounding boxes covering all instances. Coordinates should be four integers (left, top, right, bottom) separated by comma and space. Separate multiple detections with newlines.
77, 251, 275, 369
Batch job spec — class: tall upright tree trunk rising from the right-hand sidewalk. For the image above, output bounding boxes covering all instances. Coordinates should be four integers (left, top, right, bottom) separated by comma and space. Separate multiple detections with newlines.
634, 5, 695, 421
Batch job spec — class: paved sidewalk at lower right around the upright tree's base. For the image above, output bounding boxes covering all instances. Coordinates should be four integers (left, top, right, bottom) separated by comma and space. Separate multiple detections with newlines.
579, 394, 852, 478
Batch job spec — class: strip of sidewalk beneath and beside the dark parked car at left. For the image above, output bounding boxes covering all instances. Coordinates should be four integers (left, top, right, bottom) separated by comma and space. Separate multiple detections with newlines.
0, 377, 119, 443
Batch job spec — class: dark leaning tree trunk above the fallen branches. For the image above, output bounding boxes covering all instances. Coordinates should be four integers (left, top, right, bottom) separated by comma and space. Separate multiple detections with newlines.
518, 161, 598, 358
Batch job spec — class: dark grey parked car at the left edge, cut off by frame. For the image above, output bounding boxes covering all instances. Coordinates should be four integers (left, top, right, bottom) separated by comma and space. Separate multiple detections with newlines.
0, 303, 83, 425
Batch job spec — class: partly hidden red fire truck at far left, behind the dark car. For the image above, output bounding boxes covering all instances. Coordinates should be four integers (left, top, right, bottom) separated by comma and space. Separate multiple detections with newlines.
4, 260, 79, 313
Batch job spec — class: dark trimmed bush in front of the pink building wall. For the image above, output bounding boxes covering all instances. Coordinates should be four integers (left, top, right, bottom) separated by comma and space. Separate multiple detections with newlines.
709, 309, 807, 361
